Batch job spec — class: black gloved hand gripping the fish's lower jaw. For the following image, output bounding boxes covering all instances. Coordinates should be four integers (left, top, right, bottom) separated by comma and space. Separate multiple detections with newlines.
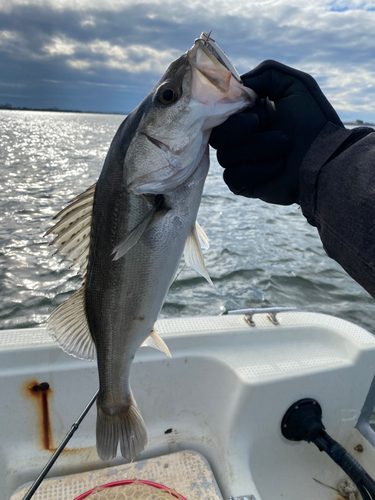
210, 61, 344, 205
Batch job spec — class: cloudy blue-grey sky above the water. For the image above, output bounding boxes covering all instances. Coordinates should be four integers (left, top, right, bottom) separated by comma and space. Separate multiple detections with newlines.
0, 0, 375, 123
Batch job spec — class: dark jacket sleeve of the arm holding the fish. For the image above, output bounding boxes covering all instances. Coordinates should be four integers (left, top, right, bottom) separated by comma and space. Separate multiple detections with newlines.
300, 123, 375, 298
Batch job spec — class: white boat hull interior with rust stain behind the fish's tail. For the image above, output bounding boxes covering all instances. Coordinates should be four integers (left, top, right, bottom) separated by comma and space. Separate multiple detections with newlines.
0, 312, 375, 500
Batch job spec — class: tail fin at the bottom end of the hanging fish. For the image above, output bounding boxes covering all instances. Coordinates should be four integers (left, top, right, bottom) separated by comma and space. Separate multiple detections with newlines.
96, 394, 148, 461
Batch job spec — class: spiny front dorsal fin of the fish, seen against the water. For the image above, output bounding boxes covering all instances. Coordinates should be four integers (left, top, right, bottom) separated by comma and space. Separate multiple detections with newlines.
45, 183, 96, 275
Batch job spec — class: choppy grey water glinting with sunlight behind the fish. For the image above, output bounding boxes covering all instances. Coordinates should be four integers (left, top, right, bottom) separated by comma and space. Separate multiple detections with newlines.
0, 111, 375, 332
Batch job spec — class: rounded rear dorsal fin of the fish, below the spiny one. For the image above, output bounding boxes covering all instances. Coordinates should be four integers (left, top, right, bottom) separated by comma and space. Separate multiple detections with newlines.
47, 285, 96, 361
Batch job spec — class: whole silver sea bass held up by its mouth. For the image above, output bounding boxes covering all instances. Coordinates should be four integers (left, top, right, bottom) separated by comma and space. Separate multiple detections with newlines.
47, 34, 256, 460
